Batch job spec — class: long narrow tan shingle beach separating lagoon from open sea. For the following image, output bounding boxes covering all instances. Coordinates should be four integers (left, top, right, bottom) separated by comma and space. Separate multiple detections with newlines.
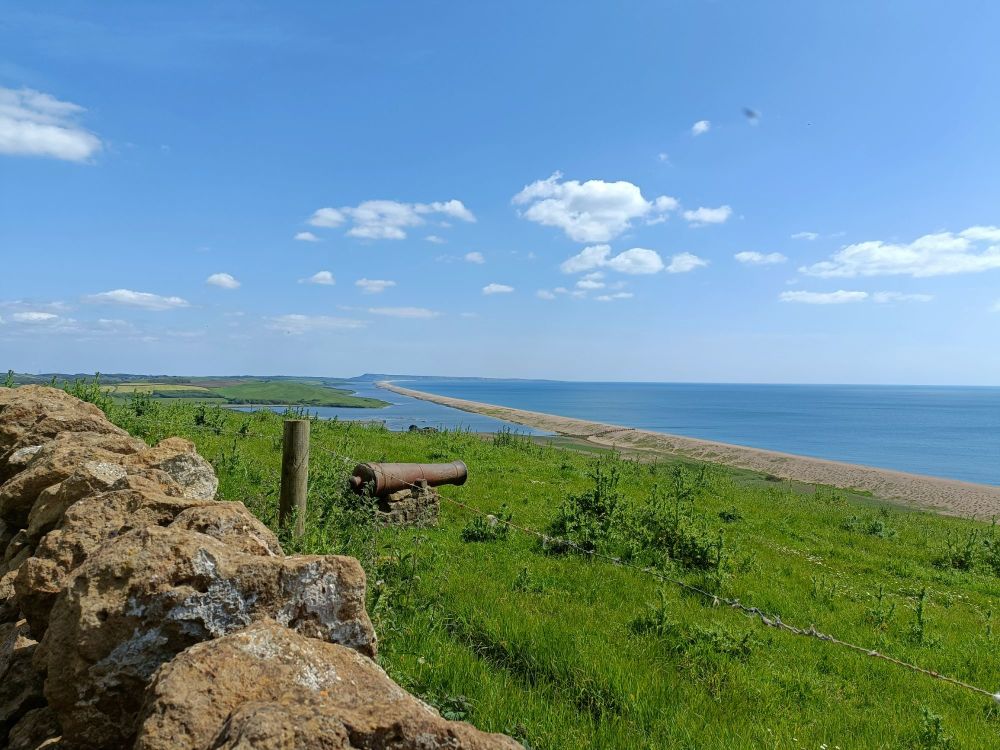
377, 382, 1000, 520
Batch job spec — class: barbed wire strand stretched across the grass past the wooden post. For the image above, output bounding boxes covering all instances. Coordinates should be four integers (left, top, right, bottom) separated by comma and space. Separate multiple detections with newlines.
174, 418, 1000, 704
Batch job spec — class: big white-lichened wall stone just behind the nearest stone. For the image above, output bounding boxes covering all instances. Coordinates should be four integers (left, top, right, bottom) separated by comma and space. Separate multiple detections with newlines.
41, 526, 375, 748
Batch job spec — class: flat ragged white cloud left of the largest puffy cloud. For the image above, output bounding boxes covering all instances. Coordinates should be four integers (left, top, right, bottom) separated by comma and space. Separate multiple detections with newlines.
309, 200, 476, 242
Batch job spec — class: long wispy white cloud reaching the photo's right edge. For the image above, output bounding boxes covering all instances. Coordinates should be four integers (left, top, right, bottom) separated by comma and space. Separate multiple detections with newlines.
799, 227, 1000, 278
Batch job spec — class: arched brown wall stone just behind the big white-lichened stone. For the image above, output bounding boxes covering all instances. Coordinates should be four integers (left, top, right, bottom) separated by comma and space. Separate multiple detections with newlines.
15, 488, 208, 638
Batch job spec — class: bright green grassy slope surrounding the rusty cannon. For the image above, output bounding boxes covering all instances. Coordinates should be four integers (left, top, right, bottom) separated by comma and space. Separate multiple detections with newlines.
90, 398, 1000, 750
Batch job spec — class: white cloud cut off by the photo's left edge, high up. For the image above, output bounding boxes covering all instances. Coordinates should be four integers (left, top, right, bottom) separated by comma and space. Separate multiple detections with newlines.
0, 87, 101, 161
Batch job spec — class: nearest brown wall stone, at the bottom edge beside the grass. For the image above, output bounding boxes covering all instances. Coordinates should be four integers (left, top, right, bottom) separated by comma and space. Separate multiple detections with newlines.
134, 620, 521, 750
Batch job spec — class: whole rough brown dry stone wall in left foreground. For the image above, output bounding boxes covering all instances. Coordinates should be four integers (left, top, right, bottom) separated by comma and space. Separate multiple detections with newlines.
0, 386, 520, 750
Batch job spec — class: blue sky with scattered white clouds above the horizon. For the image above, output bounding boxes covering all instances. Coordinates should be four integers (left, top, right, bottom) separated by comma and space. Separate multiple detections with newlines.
0, 0, 1000, 385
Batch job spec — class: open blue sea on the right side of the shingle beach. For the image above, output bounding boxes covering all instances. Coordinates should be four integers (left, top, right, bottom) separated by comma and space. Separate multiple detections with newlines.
398, 378, 1000, 485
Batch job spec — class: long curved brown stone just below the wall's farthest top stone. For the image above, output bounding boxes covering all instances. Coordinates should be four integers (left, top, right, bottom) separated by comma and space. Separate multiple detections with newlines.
0, 434, 142, 528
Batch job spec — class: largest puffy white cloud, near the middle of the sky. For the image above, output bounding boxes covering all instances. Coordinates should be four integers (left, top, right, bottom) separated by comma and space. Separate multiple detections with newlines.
511, 172, 678, 242
